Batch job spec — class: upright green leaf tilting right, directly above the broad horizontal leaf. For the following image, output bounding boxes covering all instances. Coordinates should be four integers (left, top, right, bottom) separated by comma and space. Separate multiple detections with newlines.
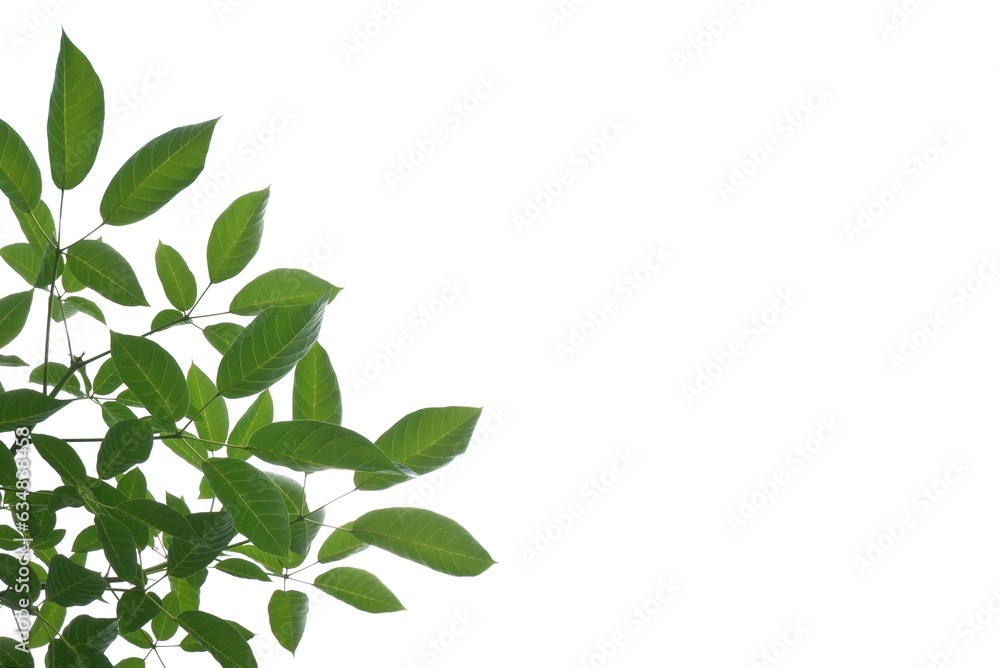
208, 188, 271, 283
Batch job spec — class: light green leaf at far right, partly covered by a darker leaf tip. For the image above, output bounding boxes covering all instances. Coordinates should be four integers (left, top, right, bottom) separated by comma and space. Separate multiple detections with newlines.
354, 407, 483, 490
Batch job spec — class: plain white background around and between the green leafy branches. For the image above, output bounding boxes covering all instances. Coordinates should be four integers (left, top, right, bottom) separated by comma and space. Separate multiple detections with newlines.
0, 0, 1000, 668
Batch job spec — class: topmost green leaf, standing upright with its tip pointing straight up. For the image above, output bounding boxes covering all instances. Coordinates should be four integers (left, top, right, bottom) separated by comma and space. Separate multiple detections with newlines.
48, 32, 104, 190
